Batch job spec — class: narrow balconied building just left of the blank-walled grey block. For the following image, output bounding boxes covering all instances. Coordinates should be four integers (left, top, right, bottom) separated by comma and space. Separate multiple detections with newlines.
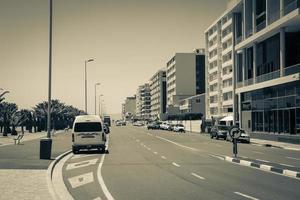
150, 69, 167, 120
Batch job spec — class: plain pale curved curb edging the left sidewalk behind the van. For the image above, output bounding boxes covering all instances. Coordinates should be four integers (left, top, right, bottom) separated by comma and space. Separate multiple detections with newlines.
47, 150, 72, 200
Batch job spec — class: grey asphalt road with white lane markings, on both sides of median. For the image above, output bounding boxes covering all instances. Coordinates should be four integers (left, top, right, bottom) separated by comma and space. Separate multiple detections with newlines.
62, 126, 300, 200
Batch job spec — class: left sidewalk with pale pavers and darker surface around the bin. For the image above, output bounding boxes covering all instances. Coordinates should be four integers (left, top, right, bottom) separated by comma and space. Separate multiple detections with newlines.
0, 132, 71, 200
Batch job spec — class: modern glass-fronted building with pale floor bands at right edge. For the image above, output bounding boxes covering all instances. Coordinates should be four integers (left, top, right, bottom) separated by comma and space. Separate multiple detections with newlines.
233, 0, 300, 135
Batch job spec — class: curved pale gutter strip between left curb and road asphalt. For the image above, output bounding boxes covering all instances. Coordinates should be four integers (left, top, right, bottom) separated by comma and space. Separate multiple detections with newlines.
52, 153, 73, 200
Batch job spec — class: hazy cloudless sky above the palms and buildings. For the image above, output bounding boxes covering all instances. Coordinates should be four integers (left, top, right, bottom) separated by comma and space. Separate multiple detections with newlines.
0, 0, 227, 113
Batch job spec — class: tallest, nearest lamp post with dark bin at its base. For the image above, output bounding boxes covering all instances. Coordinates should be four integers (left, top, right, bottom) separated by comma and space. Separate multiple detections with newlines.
40, 0, 53, 159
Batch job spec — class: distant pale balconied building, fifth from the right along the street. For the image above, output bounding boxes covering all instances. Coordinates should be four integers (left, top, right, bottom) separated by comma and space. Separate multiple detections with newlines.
136, 83, 151, 120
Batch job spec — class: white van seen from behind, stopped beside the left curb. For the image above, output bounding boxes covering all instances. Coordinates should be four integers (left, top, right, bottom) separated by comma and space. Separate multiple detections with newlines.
72, 115, 106, 154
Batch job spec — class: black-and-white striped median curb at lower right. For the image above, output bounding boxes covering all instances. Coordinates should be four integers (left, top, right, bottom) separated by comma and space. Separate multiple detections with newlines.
224, 156, 300, 179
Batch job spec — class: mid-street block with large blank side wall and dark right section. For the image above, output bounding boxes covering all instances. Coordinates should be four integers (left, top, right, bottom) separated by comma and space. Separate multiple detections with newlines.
167, 49, 205, 114
